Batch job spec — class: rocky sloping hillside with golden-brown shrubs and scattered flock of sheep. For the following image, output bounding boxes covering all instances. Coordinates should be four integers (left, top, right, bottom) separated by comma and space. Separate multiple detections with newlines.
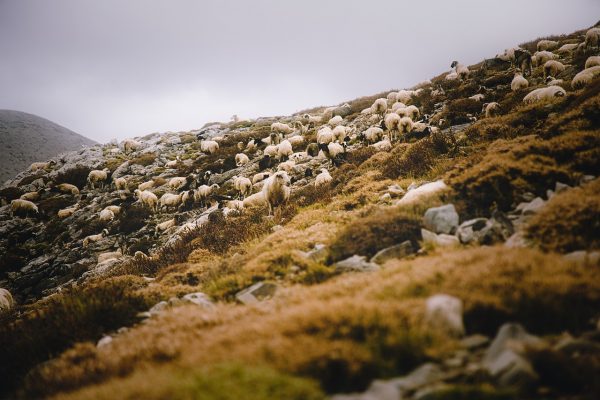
0, 25, 600, 400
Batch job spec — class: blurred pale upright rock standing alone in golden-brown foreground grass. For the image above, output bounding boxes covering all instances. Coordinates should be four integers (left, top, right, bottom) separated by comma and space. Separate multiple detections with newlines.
425, 294, 465, 337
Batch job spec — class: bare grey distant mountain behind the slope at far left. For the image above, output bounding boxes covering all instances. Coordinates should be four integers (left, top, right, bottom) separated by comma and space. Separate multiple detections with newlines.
0, 110, 96, 184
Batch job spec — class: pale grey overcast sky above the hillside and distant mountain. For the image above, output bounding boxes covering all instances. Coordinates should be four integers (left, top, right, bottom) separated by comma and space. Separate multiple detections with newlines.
0, 0, 600, 142
